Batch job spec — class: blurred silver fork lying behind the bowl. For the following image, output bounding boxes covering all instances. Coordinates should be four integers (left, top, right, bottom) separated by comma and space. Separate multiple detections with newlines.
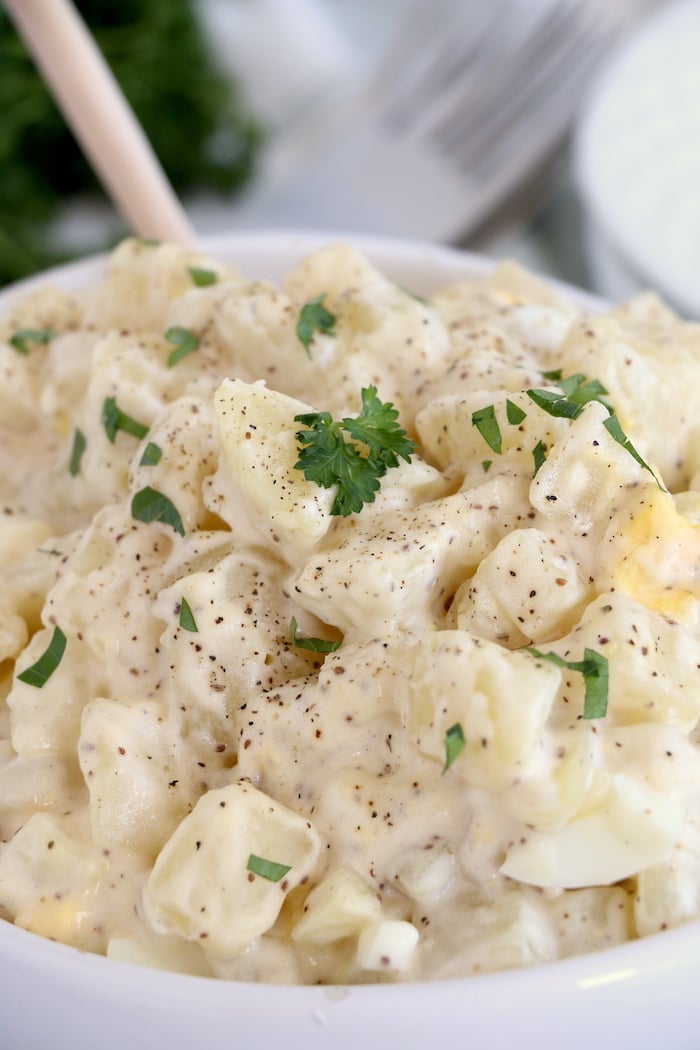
227, 0, 620, 240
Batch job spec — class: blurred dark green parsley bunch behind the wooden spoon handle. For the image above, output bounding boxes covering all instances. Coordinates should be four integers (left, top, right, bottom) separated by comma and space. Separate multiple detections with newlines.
0, 0, 262, 284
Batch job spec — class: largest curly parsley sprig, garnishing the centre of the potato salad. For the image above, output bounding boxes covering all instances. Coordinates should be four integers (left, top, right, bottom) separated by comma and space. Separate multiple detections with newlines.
294, 386, 415, 517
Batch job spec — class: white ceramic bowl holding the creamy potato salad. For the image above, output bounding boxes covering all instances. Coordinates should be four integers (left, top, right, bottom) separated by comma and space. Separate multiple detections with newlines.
0, 234, 700, 1050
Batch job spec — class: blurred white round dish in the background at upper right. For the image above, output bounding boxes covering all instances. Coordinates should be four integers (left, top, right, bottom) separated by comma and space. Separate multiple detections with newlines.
574, 0, 700, 318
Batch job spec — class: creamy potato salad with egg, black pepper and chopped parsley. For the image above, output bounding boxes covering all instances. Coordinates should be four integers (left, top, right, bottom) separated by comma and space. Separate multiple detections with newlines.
0, 239, 700, 984
